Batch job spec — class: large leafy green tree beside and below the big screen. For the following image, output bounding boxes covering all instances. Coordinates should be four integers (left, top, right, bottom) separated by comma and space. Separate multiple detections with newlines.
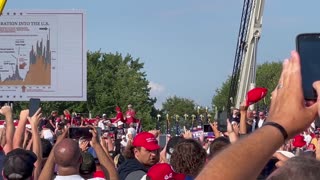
14, 51, 156, 129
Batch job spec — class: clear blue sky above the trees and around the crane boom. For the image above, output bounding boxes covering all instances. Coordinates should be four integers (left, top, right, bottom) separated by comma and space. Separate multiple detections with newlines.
5, 0, 320, 107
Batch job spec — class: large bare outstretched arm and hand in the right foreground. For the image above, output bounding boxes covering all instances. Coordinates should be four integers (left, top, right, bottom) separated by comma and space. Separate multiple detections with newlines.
197, 51, 320, 179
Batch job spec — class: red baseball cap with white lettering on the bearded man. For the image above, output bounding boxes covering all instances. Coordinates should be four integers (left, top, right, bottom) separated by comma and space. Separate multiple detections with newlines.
132, 132, 160, 151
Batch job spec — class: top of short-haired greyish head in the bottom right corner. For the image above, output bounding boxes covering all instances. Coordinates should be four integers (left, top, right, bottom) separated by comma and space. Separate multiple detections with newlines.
267, 156, 320, 180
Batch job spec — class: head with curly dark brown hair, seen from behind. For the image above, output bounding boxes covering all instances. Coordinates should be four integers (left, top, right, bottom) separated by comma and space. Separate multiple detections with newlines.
170, 139, 207, 177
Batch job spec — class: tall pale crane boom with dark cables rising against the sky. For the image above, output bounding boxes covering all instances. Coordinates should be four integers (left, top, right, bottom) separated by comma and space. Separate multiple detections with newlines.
228, 0, 265, 108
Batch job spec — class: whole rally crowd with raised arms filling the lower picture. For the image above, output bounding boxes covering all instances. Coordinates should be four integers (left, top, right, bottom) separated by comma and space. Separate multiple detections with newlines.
0, 52, 320, 180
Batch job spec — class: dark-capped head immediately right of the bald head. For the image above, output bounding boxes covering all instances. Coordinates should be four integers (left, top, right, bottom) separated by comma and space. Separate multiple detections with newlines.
79, 152, 96, 179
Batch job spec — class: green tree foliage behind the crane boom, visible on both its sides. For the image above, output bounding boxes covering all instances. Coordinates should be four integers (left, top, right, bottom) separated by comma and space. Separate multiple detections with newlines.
212, 62, 282, 110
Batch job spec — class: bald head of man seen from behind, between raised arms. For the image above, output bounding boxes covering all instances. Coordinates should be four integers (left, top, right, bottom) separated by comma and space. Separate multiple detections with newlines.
54, 139, 81, 167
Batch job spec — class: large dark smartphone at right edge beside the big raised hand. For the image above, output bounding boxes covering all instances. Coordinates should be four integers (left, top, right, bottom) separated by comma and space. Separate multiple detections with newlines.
296, 33, 320, 100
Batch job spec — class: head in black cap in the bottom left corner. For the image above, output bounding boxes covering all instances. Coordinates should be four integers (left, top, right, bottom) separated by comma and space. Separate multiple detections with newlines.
2, 148, 37, 180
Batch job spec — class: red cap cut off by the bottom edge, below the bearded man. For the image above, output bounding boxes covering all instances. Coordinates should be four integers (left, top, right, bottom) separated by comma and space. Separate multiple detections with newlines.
147, 163, 186, 180
